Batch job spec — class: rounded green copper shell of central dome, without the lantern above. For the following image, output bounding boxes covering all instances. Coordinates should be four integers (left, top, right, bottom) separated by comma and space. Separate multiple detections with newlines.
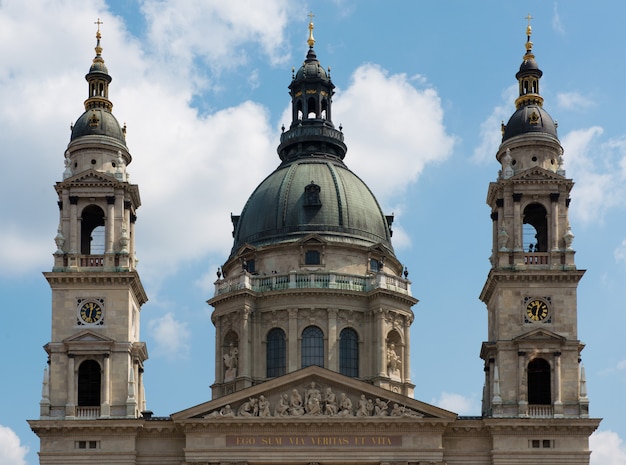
232, 159, 393, 254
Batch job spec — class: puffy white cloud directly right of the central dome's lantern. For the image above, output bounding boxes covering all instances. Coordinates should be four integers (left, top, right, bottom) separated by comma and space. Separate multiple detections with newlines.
333, 64, 455, 209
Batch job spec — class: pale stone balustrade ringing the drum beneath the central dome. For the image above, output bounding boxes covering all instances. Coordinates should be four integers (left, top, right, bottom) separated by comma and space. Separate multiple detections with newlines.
215, 272, 411, 295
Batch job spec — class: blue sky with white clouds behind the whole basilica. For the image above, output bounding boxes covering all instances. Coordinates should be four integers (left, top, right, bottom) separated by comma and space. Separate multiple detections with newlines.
0, 0, 626, 465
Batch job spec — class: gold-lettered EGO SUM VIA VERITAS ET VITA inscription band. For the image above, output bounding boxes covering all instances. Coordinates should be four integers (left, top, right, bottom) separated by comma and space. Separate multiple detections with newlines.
226, 434, 402, 447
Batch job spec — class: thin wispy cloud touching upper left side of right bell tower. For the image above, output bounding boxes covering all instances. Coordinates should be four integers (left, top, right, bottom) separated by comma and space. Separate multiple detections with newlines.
471, 84, 518, 164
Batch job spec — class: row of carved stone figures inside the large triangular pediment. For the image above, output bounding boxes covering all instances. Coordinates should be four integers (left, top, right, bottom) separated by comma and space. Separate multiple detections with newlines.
204, 382, 423, 418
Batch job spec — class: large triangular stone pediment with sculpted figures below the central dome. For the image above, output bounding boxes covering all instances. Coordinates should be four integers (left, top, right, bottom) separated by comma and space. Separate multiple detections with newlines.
172, 366, 456, 421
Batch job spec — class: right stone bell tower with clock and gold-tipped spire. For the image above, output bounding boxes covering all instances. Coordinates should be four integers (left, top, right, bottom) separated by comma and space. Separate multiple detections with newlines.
480, 18, 589, 418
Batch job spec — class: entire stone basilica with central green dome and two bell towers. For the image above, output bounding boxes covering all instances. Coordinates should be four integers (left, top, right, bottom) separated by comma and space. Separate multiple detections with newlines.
29, 17, 600, 465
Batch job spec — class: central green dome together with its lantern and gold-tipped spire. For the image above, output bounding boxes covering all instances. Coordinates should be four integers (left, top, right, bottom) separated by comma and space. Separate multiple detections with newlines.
231, 23, 393, 258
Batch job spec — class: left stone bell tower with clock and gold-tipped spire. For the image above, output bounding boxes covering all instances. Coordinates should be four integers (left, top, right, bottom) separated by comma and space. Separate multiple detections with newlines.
40, 20, 148, 419
